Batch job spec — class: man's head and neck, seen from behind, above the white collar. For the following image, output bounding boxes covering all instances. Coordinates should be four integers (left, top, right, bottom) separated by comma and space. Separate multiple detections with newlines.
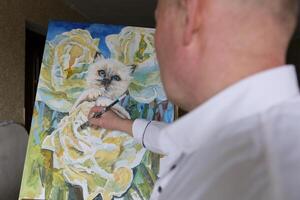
155, 0, 298, 110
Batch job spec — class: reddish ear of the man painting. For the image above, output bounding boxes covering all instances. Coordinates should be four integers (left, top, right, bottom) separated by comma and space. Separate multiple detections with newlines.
180, 0, 206, 45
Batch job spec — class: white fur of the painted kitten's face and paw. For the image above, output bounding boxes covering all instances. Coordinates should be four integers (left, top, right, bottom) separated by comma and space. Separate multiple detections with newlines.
70, 57, 132, 112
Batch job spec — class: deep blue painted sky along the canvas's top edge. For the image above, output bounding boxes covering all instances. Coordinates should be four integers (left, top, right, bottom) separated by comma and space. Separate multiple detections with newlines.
47, 21, 124, 58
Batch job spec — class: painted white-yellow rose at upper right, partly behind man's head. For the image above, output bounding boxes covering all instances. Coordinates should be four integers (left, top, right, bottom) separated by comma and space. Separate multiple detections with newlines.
106, 27, 166, 103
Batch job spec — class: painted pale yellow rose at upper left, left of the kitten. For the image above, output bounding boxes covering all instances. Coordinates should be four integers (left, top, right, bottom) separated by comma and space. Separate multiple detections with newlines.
37, 29, 99, 112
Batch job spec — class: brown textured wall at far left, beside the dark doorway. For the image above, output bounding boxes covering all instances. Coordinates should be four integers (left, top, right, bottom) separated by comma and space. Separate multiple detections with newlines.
0, 0, 85, 124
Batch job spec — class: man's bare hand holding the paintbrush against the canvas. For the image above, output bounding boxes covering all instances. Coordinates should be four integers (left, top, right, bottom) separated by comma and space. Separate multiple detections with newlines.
88, 106, 133, 136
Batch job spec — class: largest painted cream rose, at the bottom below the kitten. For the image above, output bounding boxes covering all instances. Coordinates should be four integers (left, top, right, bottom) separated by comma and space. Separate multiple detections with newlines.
42, 99, 146, 200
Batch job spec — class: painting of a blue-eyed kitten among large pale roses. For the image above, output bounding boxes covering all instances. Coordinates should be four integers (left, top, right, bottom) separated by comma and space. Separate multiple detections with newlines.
19, 21, 174, 200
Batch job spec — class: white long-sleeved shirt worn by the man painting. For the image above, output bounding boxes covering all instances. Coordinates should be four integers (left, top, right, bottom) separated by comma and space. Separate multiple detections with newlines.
133, 66, 300, 200
